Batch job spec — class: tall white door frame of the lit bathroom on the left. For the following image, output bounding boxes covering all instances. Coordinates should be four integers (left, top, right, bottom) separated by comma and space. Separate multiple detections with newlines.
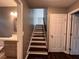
15, 0, 24, 59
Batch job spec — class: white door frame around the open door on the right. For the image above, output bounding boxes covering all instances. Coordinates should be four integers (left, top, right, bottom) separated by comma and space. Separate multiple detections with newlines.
65, 8, 79, 54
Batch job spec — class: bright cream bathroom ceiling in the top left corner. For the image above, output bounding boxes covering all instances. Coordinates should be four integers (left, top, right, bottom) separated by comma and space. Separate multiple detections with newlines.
0, 0, 17, 7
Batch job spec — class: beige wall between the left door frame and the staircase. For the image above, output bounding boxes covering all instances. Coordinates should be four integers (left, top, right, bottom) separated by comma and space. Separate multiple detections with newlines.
23, 1, 33, 58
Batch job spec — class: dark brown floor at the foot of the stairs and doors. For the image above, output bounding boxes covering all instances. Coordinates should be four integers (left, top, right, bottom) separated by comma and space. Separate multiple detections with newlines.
28, 53, 79, 59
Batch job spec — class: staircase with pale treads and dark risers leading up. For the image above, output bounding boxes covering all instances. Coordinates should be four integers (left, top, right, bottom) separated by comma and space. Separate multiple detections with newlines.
28, 25, 48, 59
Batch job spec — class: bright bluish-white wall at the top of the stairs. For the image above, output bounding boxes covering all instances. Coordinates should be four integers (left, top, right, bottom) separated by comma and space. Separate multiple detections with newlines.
33, 9, 44, 25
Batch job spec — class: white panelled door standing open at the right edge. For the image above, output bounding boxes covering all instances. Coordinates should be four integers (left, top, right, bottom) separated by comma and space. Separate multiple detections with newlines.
70, 15, 79, 55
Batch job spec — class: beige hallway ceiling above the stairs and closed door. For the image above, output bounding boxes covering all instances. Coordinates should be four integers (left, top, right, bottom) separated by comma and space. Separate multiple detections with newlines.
28, 0, 77, 8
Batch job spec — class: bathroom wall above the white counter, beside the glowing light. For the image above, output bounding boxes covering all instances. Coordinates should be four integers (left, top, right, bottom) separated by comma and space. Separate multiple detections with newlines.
0, 7, 17, 36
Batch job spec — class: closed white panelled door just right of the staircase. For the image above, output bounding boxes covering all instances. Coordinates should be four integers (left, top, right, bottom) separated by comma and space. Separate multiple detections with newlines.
49, 14, 67, 52
